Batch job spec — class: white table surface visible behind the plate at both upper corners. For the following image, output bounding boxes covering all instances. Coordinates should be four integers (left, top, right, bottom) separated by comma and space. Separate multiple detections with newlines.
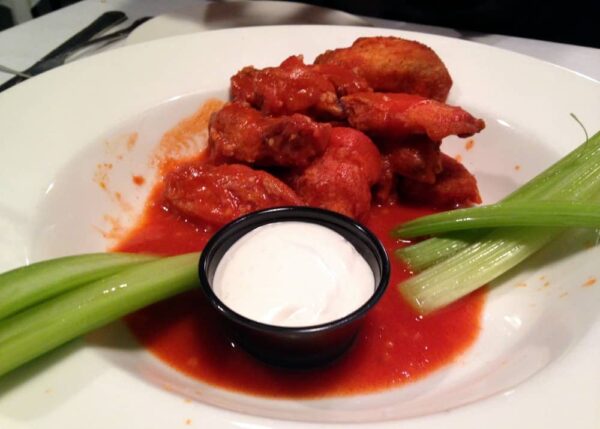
0, 0, 600, 83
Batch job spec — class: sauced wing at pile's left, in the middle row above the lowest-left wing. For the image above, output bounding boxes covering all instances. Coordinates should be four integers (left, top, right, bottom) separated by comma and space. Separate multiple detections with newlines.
208, 103, 331, 167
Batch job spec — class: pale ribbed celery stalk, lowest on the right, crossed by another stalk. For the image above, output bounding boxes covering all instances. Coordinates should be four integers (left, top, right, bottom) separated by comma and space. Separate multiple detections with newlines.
398, 134, 600, 313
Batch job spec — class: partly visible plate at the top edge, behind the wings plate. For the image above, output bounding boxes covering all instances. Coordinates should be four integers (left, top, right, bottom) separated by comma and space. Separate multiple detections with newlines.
127, 0, 369, 44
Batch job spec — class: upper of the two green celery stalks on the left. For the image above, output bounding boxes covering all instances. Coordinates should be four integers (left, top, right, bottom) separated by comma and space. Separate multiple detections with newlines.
0, 253, 156, 319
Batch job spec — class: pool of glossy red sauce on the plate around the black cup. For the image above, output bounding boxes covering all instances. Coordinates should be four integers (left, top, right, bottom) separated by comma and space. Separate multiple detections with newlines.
117, 185, 484, 397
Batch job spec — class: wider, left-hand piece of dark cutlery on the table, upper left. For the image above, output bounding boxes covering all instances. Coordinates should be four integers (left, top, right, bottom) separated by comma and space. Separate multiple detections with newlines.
0, 11, 127, 92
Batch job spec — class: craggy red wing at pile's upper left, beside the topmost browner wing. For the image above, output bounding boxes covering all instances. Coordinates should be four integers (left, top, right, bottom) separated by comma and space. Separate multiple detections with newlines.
231, 56, 370, 119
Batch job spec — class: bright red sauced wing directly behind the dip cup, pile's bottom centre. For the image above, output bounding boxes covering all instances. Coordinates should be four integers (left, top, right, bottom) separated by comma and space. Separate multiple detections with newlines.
293, 127, 382, 219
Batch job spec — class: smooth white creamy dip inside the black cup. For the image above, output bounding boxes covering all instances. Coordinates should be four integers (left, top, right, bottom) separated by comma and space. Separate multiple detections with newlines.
213, 221, 375, 326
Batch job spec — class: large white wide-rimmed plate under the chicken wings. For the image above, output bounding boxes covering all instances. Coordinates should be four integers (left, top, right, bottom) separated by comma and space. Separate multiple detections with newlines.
0, 26, 600, 429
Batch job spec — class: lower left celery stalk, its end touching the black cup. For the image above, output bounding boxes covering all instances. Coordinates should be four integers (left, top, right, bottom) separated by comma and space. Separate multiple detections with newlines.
0, 253, 199, 376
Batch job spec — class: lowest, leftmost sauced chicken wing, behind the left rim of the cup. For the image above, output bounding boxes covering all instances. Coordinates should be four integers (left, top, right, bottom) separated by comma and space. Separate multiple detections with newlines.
164, 163, 303, 225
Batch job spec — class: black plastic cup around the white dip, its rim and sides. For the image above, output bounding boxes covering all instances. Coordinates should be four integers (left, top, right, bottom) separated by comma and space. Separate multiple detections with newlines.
199, 207, 390, 368
